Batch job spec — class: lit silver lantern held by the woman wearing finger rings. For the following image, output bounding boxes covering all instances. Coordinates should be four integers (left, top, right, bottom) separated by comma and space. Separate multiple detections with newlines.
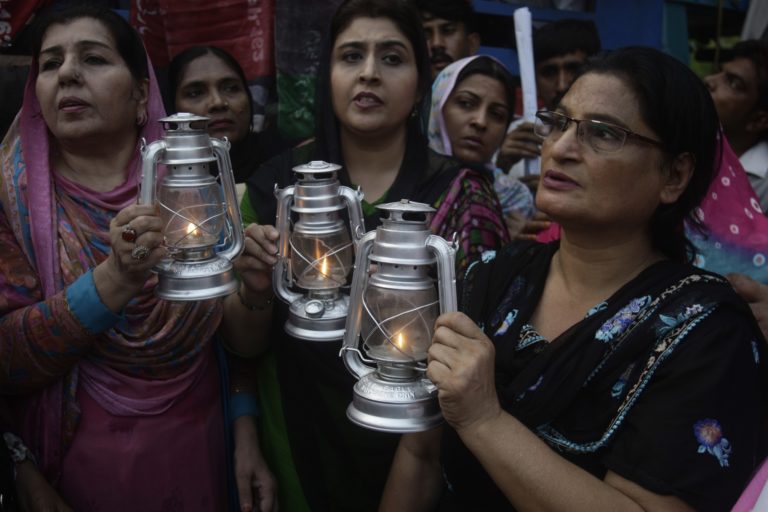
140, 113, 244, 300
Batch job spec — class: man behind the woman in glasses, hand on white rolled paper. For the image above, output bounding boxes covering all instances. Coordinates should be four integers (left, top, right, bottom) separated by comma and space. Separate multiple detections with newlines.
497, 19, 600, 175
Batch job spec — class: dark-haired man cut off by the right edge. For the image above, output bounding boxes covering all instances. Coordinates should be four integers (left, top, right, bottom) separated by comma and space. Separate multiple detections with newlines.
704, 40, 768, 212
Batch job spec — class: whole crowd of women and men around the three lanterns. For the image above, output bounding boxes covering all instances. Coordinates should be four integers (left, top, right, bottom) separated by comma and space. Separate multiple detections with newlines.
0, 0, 768, 512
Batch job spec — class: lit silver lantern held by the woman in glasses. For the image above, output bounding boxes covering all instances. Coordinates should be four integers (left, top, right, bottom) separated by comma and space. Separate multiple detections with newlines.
341, 200, 457, 432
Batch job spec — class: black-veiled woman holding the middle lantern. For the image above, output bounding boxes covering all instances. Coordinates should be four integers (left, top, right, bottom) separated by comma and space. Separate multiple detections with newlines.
234, 0, 507, 511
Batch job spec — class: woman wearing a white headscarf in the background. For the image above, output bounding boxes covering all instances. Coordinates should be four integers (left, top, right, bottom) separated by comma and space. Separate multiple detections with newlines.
429, 56, 534, 238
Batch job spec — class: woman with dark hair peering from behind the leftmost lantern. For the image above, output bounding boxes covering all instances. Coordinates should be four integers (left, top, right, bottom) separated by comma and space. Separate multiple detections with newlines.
168, 46, 264, 183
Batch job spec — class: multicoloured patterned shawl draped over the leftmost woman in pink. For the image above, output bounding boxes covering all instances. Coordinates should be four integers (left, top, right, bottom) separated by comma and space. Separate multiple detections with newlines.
0, 46, 223, 478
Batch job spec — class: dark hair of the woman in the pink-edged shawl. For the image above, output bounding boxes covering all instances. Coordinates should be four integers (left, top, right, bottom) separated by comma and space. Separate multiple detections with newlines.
32, 4, 149, 81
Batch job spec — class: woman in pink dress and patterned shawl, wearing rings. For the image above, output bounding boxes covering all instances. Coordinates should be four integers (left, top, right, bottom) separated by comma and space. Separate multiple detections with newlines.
0, 7, 274, 510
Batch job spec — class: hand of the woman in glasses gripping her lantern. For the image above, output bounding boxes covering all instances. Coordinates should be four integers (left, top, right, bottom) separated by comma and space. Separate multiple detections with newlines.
427, 313, 501, 431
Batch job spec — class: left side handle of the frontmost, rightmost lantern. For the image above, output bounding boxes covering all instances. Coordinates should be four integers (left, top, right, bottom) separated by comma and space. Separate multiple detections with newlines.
339, 231, 376, 379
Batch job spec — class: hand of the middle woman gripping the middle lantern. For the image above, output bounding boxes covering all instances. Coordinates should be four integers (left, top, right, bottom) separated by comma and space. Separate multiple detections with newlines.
235, 224, 280, 295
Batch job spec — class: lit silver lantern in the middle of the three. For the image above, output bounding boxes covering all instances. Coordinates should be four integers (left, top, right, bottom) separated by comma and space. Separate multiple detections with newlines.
272, 161, 364, 341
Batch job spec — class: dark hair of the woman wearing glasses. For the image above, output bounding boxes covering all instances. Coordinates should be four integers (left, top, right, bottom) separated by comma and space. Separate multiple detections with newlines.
581, 47, 720, 262
